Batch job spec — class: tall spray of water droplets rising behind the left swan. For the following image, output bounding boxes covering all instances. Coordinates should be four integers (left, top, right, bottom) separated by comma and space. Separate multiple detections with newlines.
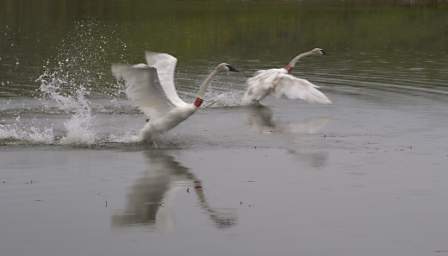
31, 21, 126, 145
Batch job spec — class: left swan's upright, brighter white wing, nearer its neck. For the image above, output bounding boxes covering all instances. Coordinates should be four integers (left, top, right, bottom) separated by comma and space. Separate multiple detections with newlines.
145, 52, 187, 107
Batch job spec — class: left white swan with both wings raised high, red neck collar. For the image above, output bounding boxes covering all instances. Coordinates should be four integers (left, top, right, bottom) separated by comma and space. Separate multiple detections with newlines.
112, 52, 237, 140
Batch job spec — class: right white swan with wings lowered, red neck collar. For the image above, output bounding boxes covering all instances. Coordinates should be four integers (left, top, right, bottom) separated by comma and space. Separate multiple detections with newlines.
242, 48, 331, 105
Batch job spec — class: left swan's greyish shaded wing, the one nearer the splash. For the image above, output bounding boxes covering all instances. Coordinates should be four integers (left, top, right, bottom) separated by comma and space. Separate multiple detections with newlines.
112, 64, 175, 119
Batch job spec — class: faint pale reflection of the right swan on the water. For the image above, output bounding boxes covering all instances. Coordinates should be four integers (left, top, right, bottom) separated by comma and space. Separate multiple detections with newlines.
247, 104, 331, 168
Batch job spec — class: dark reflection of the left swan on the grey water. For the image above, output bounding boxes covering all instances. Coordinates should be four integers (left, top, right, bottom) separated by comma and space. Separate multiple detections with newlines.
112, 150, 237, 232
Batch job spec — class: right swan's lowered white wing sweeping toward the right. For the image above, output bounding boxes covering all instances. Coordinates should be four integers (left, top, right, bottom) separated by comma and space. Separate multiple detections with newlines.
274, 74, 331, 104
